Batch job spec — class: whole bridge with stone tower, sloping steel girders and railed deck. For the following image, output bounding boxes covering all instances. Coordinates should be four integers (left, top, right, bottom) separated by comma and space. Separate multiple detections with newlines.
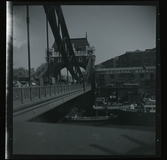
13, 3, 95, 121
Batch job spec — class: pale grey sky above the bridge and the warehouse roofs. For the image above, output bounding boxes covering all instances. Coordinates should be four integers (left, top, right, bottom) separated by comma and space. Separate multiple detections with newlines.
13, 5, 156, 69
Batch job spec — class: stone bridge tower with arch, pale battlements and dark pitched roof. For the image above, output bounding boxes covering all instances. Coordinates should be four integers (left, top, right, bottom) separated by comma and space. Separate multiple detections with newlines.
43, 37, 95, 83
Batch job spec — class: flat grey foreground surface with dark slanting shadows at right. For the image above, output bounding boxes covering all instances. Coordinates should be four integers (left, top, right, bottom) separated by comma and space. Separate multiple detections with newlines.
13, 122, 156, 155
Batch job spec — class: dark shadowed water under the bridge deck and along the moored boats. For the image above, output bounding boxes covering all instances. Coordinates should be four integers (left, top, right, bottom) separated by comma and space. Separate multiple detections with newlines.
29, 103, 155, 132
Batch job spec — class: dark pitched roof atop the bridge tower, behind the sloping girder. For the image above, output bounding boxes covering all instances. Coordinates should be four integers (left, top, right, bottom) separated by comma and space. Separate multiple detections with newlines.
52, 38, 90, 52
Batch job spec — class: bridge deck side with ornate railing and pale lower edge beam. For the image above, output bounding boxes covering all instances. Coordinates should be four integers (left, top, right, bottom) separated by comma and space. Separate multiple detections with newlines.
13, 84, 91, 121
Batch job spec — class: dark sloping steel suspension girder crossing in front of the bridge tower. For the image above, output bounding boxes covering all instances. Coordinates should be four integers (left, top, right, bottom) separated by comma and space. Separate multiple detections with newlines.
43, 5, 83, 80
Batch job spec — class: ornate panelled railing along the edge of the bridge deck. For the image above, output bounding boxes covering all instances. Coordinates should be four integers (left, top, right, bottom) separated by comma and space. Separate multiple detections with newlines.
13, 84, 90, 107
